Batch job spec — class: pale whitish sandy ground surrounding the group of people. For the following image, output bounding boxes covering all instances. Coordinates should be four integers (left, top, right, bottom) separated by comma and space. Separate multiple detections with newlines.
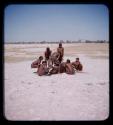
4, 43, 109, 120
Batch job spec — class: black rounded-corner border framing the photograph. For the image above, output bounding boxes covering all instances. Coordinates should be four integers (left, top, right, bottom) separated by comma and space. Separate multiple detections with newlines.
0, 2, 112, 124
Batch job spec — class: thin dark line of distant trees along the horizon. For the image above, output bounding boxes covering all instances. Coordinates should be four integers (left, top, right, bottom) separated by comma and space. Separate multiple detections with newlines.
6, 40, 109, 44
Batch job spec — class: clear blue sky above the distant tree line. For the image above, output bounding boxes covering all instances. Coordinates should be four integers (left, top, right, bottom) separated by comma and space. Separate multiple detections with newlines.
4, 4, 109, 42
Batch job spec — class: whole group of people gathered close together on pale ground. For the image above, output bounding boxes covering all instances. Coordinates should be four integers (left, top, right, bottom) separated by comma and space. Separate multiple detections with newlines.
31, 43, 83, 76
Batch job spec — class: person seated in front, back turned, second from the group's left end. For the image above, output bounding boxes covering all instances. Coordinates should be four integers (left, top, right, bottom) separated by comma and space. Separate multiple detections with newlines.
37, 61, 49, 76
